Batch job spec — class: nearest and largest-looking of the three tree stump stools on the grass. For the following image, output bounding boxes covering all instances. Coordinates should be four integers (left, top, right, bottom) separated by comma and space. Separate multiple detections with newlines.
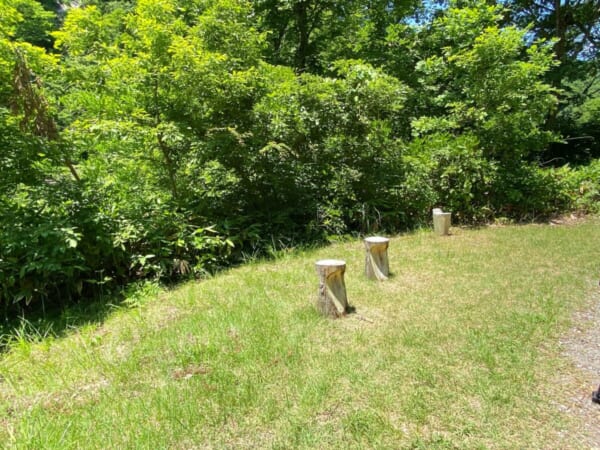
316, 259, 348, 317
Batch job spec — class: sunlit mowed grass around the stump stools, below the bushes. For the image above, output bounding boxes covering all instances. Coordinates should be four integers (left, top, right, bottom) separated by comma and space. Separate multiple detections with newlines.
0, 219, 600, 449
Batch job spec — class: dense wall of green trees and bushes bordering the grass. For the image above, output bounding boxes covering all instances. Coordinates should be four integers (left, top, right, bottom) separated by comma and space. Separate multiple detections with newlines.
0, 0, 600, 311
